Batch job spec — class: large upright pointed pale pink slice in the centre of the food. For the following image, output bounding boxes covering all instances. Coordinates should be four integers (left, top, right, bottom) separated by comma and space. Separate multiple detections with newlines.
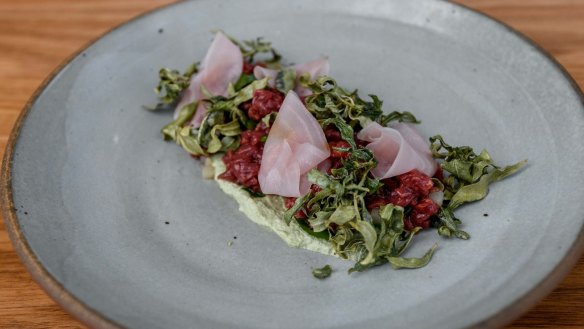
258, 91, 330, 197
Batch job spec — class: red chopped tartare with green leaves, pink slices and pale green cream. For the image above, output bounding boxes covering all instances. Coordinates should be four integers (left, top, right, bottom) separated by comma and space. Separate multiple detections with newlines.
149, 32, 526, 272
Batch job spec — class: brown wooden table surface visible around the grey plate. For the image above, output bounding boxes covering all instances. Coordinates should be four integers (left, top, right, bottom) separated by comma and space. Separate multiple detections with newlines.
0, 0, 584, 328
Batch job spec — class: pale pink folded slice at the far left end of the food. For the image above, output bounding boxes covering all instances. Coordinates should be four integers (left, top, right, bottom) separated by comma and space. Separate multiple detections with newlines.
174, 32, 243, 127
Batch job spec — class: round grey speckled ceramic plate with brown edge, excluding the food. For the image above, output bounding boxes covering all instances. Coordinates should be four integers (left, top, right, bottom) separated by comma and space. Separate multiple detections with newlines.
2, 0, 584, 328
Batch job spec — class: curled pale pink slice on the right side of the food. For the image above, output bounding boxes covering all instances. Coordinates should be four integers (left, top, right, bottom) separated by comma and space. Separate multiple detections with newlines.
357, 122, 437, 179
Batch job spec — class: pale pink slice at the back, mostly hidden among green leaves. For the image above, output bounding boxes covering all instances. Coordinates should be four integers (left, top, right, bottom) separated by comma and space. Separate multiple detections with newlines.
253, 58, 330, 97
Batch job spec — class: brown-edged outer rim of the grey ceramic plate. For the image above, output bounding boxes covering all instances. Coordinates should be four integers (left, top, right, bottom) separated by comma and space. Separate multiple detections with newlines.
0, 0, 584, 329
